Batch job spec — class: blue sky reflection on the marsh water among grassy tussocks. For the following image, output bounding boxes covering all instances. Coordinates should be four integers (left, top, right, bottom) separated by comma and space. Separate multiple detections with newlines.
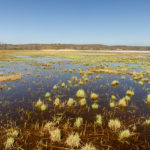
0, 57, 150, 113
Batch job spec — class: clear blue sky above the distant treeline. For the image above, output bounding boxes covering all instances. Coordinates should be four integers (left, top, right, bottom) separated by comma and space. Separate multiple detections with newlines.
0, 0, 150, 46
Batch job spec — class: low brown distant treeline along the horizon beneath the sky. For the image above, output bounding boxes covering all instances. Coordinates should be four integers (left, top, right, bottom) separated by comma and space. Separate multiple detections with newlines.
0, 44, 150, 50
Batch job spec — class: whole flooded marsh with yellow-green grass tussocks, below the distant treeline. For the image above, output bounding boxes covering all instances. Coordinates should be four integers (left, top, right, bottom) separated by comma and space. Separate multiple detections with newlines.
0, 49, 150, 150
